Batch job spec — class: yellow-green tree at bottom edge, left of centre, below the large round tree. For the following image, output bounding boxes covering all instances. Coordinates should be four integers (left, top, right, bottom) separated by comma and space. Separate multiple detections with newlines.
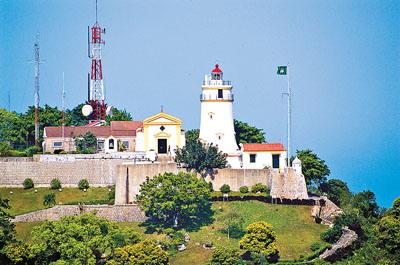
107, 240, 168, 265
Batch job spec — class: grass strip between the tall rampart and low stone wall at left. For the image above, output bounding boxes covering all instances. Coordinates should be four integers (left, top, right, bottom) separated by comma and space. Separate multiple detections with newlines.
0, 188, 108, 215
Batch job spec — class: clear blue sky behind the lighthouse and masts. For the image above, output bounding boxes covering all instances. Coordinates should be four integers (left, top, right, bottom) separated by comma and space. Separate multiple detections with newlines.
0, 0, 400, 206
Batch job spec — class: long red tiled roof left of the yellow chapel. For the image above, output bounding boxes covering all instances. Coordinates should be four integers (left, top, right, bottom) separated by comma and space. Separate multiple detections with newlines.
44, 121, 143, 137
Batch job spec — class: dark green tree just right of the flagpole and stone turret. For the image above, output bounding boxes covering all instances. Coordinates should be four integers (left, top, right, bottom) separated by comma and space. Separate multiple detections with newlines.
292, 149, 331, 187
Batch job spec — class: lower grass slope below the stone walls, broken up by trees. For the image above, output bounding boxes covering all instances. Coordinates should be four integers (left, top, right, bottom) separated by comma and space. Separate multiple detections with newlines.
16, 201, 327, 265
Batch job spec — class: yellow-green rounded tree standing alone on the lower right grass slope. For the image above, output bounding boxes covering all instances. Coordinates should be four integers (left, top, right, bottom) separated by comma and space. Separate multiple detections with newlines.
239, 221, 279, 261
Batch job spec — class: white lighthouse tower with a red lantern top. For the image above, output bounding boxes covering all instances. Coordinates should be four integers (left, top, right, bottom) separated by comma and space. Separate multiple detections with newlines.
199, 64, 241, 168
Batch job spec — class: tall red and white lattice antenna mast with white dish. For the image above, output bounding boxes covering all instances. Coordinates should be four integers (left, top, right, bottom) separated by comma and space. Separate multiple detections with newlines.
82, 0, 110, 121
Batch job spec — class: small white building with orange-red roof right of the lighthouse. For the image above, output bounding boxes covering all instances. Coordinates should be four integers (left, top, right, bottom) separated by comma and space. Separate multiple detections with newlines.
241, 143, 286, 170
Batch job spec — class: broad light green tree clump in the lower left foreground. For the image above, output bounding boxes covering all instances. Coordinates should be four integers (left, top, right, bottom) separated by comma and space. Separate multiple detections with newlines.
30, 214, 140, 265
